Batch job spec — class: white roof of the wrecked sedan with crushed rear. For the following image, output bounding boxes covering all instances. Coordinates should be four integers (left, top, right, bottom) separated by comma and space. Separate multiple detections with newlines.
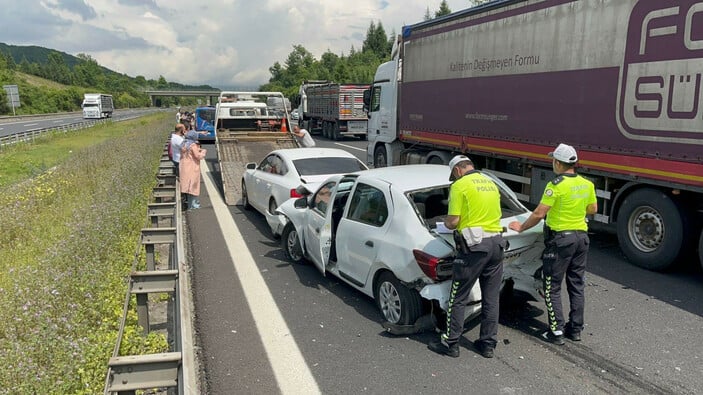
357, 165, 450, 191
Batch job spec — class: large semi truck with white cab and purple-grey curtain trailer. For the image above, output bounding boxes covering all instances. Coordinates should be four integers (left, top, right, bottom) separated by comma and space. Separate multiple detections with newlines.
365, 0, 703, 270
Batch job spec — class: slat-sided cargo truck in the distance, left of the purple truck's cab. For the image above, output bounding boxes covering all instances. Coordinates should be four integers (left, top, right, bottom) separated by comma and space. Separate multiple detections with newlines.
298, 81, 369, 140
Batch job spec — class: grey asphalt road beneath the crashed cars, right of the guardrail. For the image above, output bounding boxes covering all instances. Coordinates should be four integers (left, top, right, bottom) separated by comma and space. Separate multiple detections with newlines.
185, 136, 703, 394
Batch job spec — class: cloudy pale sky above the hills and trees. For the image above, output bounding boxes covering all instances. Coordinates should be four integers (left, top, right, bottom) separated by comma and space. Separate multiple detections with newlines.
0, 0, 471, 89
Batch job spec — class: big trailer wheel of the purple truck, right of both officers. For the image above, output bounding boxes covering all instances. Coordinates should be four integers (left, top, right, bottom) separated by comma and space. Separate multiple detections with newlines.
617, 188, 684, 271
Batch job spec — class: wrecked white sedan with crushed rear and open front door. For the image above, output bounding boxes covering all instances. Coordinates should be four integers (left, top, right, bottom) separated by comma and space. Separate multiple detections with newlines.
277, 165, 544, 334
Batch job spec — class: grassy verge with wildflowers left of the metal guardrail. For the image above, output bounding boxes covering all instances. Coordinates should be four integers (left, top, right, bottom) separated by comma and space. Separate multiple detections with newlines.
0, 114, 172, 394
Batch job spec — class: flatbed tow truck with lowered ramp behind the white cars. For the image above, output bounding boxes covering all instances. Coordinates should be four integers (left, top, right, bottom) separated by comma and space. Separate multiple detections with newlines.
214, 91, 298, 205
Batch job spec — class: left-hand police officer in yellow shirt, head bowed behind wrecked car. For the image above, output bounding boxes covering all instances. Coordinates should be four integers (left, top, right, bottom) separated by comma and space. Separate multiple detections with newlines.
428, 155, 506, 358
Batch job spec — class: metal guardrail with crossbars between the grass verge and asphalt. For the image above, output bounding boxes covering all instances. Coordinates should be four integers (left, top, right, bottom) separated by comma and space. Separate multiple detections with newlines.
104, 144, 198, 395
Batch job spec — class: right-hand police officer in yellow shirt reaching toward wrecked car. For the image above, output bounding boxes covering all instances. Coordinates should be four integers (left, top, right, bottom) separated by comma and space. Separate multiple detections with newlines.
509, 144, 598, 345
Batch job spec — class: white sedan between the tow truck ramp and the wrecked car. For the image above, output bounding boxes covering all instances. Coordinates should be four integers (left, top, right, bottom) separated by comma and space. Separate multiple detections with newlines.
242, 148, 367, 235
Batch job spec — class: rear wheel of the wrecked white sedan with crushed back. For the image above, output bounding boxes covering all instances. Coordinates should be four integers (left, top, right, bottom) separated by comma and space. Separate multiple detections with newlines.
374, 272, 422, 325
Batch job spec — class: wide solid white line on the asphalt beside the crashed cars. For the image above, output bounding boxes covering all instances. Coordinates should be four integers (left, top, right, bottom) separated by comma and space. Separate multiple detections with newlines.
200, 165, 320, 394
